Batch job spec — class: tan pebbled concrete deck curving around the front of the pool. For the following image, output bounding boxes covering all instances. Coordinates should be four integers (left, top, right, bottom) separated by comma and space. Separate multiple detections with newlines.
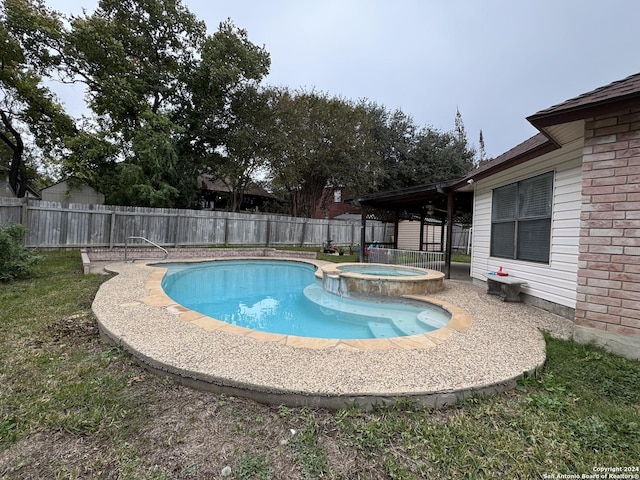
93, 259, 573, 408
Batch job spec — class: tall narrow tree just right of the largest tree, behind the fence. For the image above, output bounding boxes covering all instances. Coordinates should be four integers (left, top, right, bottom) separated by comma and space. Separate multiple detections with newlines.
188, 20, 270, 211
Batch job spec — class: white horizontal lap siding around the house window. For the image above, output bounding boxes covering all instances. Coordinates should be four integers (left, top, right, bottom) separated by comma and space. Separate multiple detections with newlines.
471, 139, 583, 308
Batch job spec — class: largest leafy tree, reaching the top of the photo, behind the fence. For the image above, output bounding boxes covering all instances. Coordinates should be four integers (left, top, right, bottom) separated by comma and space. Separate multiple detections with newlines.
57, 0, 206, 207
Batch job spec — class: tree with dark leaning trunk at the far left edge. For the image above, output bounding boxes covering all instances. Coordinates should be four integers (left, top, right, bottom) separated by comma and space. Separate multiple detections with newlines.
0, 0, 75, 197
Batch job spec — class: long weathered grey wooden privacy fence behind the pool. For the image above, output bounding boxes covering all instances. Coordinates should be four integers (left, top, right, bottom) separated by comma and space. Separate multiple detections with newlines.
0, 197, 393, 248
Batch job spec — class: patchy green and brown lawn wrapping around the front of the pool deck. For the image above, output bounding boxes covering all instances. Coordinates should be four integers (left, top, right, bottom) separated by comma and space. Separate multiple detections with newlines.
0, 252, 640, 479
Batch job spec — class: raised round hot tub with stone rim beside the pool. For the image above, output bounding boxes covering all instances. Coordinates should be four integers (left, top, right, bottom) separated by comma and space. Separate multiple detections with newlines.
317, 263, 444, 297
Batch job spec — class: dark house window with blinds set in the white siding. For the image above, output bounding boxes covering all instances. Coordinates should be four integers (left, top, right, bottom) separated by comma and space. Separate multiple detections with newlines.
491, 172, 553, 263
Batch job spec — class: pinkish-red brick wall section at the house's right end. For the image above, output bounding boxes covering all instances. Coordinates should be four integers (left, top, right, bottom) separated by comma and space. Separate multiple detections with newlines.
575, 109, 640, 336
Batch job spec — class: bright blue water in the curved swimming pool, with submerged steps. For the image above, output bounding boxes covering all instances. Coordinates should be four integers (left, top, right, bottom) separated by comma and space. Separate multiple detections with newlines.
162, 260, 450, 339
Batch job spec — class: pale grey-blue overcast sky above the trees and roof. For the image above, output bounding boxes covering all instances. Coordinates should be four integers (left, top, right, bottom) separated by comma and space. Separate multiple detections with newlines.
46, 0, 640, 157
